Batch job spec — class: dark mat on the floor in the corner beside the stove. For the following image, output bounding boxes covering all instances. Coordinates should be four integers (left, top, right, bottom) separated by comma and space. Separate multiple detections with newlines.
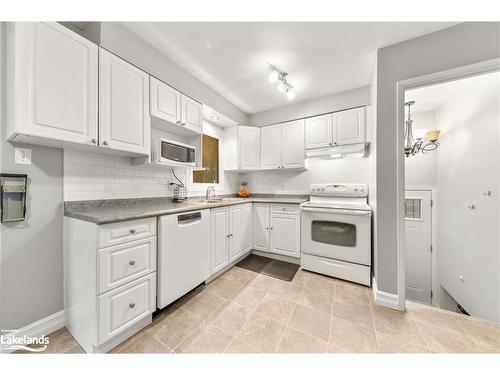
236, 254, 299, 281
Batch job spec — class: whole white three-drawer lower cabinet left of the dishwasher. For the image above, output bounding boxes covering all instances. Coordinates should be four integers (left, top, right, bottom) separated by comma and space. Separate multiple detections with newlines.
64, 217, 157, 353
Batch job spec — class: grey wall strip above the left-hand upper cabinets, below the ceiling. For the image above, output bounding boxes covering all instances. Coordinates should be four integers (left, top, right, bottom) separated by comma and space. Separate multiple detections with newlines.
100, 22, 248, 124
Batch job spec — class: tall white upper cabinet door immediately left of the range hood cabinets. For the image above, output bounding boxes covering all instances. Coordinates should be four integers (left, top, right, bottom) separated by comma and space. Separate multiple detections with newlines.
281, 120, 306, 168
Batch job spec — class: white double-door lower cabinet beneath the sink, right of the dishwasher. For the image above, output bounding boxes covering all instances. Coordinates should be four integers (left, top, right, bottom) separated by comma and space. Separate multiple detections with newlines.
211, 203, 252, 275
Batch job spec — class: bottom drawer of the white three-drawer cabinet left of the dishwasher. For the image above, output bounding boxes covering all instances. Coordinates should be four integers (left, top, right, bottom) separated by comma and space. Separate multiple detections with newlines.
98, 273, 156, 345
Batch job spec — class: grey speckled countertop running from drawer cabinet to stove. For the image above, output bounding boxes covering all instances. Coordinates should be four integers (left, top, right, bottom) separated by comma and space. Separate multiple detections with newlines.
64, 194, 309, 224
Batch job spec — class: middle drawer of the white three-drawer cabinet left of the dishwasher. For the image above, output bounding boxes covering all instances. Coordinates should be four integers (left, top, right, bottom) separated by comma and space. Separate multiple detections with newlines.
97, 237, 156, 294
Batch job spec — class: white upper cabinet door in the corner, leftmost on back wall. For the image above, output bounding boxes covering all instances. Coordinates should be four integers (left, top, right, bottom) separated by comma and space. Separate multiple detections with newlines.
238, 126, 260, 170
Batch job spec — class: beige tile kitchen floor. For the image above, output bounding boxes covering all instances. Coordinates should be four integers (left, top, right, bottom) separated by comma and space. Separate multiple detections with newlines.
15, 267, 500, 353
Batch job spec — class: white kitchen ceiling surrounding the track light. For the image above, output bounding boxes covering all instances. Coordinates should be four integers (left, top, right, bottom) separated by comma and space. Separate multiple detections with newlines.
123, 22, 453, 113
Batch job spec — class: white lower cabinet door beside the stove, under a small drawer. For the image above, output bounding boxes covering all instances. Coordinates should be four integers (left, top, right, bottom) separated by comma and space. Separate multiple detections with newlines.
270, 214, 300, 257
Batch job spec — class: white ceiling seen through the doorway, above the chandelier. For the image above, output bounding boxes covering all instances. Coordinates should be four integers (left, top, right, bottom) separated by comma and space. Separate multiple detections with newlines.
405, 72, 500, 113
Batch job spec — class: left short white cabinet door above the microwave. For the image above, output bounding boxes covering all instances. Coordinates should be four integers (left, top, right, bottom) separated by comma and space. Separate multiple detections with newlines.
149, 77, 181, 125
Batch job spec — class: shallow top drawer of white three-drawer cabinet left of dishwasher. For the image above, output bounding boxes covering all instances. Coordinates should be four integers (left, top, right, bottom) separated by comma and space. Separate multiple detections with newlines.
99, 217, 156, 248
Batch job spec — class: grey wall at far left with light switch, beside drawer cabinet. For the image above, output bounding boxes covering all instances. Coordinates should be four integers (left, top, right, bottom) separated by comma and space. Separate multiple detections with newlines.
0, 23, 63, 329
